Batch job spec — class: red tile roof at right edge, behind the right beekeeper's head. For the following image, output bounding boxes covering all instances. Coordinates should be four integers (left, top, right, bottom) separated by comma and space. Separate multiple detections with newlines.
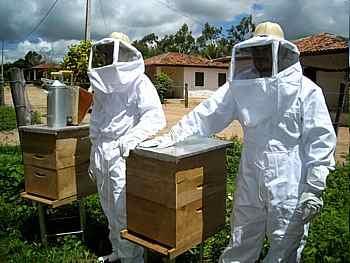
293, 33, 348, 56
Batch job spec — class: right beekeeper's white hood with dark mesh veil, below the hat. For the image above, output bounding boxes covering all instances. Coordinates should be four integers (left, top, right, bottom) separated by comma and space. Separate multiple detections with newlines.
228, 23, 302, 127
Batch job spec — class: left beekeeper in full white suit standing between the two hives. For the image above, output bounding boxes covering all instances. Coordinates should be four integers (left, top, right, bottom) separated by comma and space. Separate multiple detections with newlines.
88, 33, 166, 263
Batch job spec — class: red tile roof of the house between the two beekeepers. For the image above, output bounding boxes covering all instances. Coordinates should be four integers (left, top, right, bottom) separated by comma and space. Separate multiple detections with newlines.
145, 52, 228, 68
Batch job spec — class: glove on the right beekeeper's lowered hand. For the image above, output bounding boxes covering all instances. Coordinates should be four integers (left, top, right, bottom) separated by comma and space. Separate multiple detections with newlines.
298, 192, 323, 223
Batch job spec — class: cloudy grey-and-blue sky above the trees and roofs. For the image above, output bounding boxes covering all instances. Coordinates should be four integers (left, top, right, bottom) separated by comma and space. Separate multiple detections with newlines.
0, 0, 349, 61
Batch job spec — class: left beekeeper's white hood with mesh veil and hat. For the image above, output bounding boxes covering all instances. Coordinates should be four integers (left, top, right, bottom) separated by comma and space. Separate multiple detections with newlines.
88, 32, 145, 93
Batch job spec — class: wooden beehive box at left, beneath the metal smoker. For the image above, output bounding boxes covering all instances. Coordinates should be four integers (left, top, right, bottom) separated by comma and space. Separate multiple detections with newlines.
19, 125, 96, 200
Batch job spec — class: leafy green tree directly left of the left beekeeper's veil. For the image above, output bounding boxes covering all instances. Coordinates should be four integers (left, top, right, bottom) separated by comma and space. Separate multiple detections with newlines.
61, 40, 92, 88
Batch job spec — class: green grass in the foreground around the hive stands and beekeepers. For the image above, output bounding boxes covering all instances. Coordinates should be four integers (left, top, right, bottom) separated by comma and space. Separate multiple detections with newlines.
0, 141, 350, 263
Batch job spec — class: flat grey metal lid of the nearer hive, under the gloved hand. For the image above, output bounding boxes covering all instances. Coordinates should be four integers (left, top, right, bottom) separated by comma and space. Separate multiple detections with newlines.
133, 137, 232, 162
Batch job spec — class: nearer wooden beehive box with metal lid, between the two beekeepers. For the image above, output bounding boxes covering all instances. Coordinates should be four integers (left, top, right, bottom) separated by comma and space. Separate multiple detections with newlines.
123, 138, 231, 257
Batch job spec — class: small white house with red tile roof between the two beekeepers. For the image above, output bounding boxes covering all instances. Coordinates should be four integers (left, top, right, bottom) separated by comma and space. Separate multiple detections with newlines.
145, 52, 228, 98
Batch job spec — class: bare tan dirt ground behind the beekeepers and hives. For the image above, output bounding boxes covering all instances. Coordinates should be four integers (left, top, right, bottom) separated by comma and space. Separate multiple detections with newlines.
0, 85, 350, 163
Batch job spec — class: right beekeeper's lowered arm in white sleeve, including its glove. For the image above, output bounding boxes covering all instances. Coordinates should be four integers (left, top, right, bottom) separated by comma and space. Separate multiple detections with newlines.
300, 78, 336, 221
